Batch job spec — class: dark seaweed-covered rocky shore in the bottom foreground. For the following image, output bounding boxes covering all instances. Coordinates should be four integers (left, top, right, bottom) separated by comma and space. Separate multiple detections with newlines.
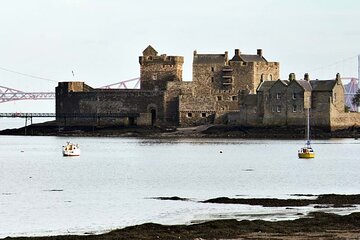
5, 212, 360, 240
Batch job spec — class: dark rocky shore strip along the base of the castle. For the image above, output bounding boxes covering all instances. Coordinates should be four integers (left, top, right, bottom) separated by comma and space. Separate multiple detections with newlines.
0, 121, 360, 140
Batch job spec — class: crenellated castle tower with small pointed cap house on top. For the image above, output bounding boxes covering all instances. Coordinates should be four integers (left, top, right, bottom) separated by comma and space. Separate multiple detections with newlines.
139, 45, 184, 90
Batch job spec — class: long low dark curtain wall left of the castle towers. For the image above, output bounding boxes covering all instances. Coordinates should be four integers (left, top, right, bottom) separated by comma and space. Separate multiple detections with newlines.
56, 84, 165, 125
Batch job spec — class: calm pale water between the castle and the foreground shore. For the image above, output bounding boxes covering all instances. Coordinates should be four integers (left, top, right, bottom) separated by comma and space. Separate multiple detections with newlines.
0, 136, 360, 238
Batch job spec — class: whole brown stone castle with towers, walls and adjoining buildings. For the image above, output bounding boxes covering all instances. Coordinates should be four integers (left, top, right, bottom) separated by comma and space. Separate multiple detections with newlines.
56, 46, 360, 129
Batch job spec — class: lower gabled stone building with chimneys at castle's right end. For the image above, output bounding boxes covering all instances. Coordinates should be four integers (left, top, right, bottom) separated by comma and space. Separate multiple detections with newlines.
229, 73, 360, 130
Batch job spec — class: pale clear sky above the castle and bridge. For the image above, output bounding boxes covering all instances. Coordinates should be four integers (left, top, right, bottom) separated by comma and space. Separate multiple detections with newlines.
0, 0, 360, 112
